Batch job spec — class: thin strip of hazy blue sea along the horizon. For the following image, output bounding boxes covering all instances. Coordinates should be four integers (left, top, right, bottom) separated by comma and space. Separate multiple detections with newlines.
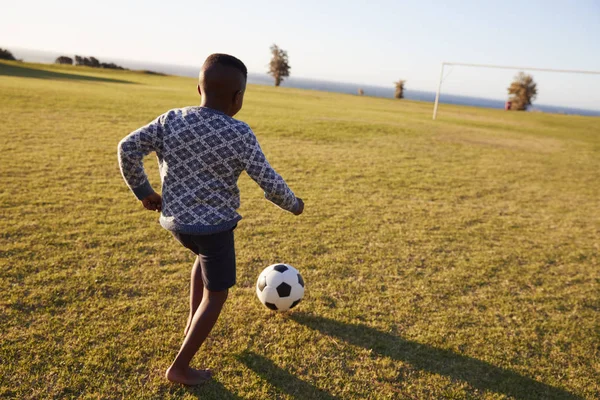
9, 49, 600, 116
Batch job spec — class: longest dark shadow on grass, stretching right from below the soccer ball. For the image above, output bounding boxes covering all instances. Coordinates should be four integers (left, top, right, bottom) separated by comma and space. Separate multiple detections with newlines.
290, 312, 581, 400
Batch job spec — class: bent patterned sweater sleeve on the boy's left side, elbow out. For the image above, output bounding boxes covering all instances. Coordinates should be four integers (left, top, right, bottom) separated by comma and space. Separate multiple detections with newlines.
118, 116, 163, 200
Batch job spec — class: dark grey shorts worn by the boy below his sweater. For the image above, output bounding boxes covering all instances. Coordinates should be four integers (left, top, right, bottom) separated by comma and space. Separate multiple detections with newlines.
171, 227, 236, 292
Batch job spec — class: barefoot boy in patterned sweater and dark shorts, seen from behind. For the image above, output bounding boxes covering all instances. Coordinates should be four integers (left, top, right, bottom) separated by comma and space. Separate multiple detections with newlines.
118, 54, 304, 385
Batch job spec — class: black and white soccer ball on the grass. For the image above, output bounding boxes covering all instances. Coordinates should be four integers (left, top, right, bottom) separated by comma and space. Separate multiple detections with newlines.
256, 264, 304, 311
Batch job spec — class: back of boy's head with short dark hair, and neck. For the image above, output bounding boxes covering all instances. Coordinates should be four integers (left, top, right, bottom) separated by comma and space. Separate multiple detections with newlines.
198, 53, 248, 117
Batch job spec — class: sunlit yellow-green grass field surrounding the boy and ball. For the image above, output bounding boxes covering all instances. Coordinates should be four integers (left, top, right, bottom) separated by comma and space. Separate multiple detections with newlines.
0, 62, 600, 399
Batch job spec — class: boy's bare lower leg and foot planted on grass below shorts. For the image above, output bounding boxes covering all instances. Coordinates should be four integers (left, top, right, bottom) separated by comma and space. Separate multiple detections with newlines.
166, 288, 228, 385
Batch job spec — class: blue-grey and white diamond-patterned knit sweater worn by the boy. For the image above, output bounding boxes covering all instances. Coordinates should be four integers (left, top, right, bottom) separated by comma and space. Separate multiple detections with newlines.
118, 107, 298, 234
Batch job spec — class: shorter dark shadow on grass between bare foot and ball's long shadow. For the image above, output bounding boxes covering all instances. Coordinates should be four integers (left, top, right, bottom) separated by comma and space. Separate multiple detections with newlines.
237, 351, 337, 400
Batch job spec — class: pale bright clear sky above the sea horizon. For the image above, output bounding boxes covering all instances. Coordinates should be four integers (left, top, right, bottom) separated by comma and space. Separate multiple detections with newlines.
0, 0, 600, 109
